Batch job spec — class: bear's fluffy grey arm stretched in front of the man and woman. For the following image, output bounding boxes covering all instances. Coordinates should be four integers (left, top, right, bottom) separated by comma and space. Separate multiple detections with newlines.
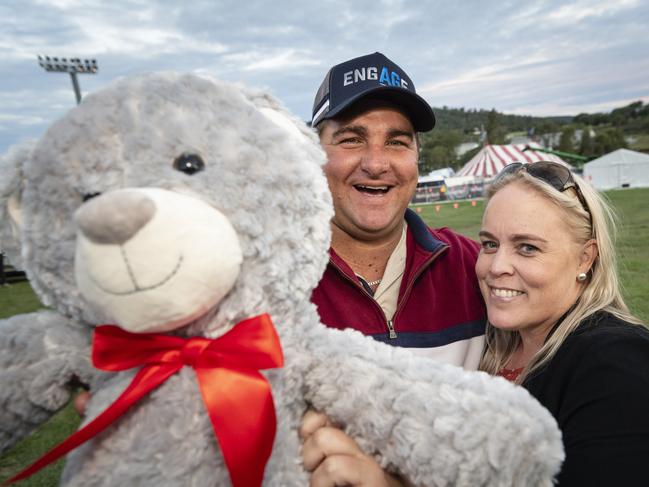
305, 330, 563, 486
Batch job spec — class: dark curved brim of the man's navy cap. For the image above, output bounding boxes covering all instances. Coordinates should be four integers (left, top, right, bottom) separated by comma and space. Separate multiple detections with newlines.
321, 86, 435, 132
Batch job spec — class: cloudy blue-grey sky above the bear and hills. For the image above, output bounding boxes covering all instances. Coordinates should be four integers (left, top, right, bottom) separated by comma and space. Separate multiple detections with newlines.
0, 0, 649, 153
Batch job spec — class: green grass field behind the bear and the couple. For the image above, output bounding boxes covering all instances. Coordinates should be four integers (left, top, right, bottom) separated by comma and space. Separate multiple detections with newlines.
0, 188, 649, 487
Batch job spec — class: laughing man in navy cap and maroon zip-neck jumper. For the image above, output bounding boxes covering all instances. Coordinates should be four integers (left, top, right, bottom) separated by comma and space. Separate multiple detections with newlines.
312, 52, 485, 369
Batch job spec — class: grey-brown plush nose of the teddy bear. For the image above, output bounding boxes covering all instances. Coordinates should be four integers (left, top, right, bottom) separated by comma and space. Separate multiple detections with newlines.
75, 190, 156, 245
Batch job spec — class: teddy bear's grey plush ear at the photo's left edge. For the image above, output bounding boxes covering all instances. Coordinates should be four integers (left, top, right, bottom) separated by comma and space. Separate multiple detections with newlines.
0, 140, 36, 269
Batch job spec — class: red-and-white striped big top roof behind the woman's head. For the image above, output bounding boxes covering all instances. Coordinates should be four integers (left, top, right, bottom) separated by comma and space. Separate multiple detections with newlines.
456, 144, 570, 178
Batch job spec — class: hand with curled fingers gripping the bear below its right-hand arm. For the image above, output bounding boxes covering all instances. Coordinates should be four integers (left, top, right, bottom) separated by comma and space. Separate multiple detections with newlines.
300, 410, 403, 487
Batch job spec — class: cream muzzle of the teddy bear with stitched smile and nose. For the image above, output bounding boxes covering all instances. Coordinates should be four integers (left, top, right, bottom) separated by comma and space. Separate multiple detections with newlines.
75, 188, 242, 332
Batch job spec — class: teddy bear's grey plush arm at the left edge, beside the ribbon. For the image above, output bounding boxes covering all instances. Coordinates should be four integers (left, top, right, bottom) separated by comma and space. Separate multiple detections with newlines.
0, 311, 97, 451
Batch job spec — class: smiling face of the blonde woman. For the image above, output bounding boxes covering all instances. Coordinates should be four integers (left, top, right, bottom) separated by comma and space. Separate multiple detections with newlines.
476, 182, 588, 339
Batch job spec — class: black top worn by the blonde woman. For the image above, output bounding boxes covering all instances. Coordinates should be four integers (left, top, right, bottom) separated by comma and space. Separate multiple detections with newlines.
523, 312, 649, 487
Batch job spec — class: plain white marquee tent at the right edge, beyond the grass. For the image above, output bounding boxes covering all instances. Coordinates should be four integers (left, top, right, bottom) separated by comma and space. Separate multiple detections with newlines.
584, 149, 649, 189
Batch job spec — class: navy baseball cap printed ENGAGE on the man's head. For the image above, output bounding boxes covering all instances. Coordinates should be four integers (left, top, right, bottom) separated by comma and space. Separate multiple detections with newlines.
311, 52, 435, 132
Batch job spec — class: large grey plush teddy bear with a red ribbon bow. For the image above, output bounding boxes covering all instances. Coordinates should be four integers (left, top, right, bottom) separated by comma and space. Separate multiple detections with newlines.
0, 73, 563, 487
